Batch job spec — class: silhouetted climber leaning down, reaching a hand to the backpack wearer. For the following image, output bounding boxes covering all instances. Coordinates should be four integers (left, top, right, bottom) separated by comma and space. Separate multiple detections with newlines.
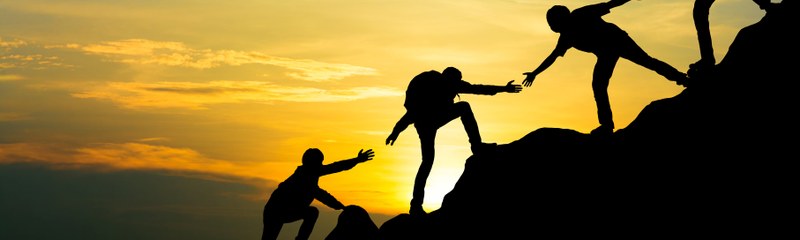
522, 0, 687, 135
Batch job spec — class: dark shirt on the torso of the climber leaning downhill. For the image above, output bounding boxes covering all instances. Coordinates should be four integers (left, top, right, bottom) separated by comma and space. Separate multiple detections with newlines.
554, 3, 628, 56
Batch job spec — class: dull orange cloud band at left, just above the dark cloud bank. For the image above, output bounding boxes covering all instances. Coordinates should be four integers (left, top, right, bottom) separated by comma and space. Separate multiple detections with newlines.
0, 142, 264, 183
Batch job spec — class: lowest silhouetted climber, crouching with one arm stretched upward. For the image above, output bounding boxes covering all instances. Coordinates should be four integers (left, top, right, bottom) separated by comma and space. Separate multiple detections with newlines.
261, 148, 375, 240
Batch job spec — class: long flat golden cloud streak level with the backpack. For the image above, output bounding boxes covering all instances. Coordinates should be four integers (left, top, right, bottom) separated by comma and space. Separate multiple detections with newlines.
72, 81, 403, 109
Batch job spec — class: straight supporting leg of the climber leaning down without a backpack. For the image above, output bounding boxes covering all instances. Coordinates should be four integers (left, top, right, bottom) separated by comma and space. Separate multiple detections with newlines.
592, 55, 619, 130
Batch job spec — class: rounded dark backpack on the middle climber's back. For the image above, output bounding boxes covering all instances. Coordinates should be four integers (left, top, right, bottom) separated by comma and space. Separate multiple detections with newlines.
403, 70, 454, 112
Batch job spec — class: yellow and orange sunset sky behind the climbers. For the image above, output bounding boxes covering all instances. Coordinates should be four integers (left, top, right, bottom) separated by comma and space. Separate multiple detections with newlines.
0, 0, 764, 239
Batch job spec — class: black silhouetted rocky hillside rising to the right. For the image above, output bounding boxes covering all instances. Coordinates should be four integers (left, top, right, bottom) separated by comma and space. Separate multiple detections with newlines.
380, 0, 800, 239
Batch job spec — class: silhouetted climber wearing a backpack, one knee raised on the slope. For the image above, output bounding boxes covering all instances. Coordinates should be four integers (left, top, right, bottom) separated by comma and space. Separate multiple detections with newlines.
386, 67, 522, 215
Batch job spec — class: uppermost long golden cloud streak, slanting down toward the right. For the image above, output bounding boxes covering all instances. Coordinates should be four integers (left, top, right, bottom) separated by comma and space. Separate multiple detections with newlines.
54, 39, 377, 82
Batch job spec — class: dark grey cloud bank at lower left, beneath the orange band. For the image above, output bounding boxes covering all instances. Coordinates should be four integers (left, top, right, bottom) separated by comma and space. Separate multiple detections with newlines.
0, 164, 266, 240
